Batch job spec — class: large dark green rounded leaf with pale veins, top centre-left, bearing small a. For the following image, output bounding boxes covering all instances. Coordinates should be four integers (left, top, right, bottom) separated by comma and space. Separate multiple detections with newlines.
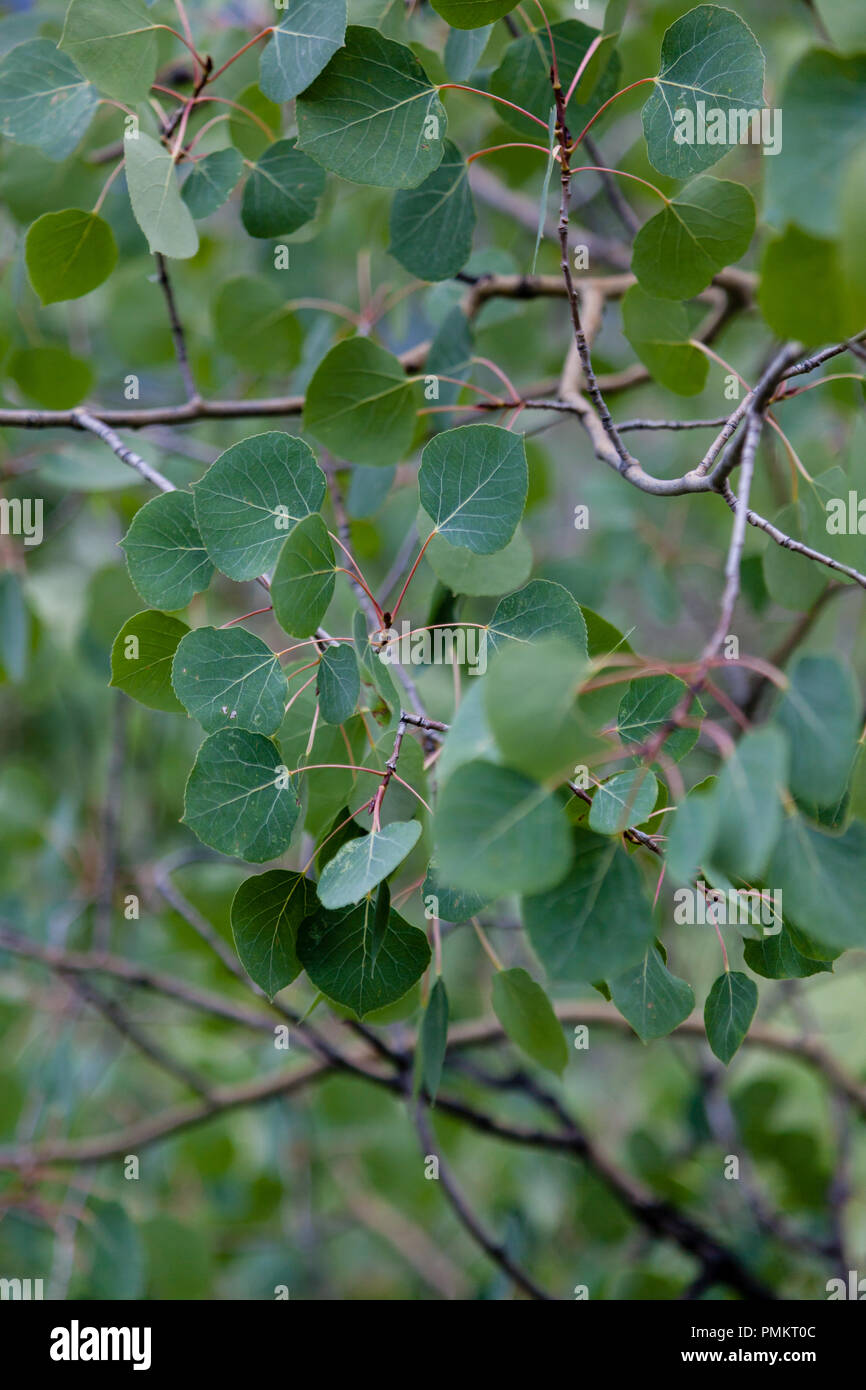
296, 25, 448, 188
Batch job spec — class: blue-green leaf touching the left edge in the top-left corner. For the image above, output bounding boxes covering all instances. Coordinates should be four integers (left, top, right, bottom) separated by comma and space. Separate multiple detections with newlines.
0, 39, 99, 160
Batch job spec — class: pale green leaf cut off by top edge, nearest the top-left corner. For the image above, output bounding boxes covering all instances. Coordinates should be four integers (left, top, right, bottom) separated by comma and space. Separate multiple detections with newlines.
60, 0, 157, 106
